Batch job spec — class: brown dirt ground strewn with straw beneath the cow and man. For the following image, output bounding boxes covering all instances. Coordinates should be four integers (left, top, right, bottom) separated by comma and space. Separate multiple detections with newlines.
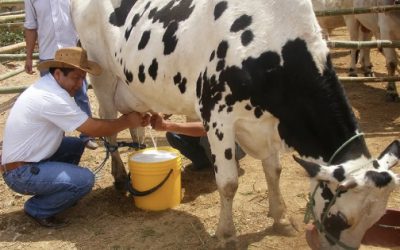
0, 26, 400, 250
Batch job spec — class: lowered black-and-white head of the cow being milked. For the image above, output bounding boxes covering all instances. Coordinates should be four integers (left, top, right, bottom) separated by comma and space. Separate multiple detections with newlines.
295, 141, 400, 249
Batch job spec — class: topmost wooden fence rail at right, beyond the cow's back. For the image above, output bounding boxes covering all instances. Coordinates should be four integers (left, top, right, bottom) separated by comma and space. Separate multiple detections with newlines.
315, 5, 400, 17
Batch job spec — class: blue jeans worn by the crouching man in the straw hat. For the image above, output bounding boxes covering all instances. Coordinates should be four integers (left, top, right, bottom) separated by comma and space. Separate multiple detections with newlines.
3, 137, 94, 218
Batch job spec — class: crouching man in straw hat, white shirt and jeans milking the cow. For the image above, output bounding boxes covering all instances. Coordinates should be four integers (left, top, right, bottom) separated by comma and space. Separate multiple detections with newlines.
0, 47, 150, 228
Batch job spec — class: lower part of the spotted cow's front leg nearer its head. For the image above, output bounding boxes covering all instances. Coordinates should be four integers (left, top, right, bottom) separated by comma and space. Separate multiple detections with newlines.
262, 153, 296, 236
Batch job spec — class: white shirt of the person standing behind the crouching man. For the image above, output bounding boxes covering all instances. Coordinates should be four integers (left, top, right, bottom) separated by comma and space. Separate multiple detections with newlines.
24, 0, 78, 60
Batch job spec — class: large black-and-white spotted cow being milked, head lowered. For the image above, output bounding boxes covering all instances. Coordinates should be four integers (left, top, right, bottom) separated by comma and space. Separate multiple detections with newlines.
72, 0, 400, 248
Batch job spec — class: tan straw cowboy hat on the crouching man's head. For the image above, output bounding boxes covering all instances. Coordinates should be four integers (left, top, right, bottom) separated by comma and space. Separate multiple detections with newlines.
37, 47, 102, 76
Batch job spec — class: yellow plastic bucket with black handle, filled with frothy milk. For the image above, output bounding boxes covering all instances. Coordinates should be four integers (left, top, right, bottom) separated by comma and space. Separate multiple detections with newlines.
128, 147, 181, 211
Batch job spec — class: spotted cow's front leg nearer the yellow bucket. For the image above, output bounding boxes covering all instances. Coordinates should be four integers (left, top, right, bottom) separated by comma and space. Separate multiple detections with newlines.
208, 132, 238, 249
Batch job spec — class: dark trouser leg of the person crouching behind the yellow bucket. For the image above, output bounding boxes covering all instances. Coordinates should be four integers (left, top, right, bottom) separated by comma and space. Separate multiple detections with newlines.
166, 132, 212, 170
